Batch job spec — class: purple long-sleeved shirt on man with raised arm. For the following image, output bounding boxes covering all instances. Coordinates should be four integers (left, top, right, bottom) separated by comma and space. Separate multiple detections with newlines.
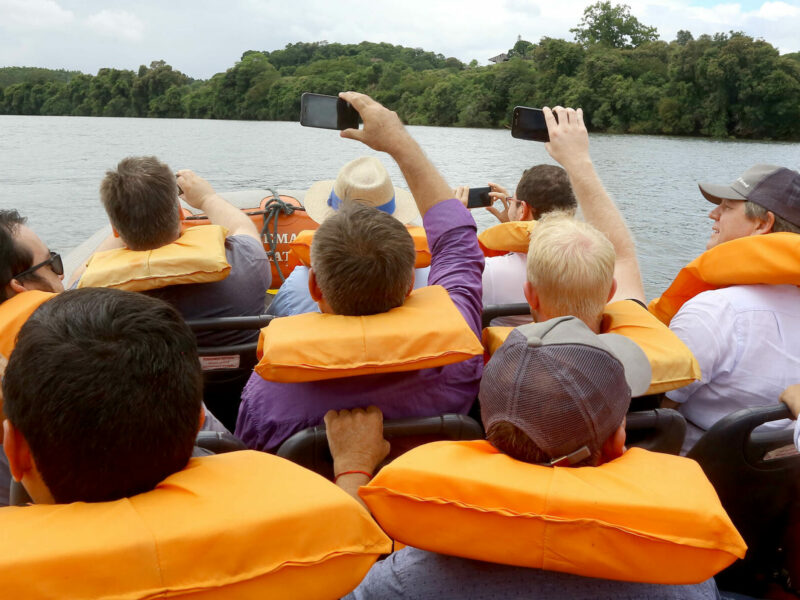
236, 199, 483, 451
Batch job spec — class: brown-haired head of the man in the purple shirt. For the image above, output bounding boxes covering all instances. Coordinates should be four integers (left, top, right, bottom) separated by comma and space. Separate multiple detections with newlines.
311, 202, 415, 316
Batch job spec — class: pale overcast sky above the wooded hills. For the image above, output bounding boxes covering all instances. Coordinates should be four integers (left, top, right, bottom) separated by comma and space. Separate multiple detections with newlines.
0, 0, 800, 79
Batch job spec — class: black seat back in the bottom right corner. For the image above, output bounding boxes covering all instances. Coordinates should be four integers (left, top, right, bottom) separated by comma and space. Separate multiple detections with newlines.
687, 403, 800, 597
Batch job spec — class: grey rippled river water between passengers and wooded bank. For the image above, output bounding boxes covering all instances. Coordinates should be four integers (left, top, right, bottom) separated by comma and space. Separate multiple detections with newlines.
0, 116, 800, 298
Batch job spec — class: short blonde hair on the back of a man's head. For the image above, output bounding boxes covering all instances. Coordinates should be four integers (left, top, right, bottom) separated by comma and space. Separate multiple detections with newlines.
527, 213, 616, 327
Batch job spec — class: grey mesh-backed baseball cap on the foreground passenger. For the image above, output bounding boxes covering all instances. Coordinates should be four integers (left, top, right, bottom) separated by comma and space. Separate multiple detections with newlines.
479, 317, 652, 463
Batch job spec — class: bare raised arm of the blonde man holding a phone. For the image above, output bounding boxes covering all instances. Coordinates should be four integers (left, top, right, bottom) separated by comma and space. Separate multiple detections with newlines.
544, 106, 645, 302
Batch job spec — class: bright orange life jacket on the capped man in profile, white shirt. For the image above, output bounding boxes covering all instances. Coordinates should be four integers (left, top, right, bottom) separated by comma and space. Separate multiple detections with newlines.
648, 232, 800, 325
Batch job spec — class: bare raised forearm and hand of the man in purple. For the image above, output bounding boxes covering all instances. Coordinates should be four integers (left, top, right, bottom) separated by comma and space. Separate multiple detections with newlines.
339, 92, 453, 216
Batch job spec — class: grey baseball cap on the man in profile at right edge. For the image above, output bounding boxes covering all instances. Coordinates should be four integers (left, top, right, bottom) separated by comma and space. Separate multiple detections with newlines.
697, 165, 800, 227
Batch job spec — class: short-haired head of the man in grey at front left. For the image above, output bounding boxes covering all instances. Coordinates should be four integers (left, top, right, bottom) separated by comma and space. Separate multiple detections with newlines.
100, 156, 180, 250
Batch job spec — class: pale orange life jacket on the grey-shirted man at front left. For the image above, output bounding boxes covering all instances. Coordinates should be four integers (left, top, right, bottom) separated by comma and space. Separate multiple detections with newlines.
78, 225, 231, 292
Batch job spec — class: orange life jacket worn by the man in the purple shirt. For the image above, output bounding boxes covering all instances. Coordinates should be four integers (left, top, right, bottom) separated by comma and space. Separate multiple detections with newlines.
255, 285, 483, 382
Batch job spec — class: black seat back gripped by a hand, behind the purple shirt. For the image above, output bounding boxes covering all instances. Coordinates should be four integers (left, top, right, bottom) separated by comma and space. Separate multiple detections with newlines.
278, 415, 484, 479
